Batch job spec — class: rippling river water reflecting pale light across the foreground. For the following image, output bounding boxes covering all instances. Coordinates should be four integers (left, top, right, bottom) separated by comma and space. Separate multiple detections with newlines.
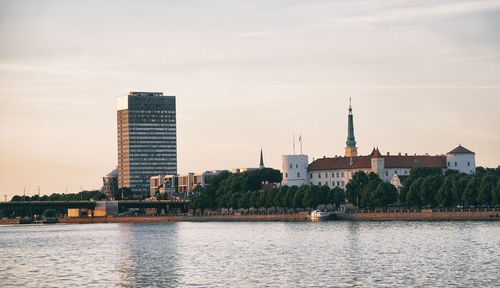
0, 222, 500, 287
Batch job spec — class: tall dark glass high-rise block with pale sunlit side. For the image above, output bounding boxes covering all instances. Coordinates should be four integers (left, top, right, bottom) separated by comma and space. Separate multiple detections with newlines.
117, 92, 177, 197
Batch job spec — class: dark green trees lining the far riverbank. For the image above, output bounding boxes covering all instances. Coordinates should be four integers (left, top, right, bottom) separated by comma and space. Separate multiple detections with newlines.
4, 167, 500, 213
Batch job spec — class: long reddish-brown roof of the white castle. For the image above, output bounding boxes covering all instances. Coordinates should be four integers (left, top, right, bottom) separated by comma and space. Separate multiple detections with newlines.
309, 154, 446, 170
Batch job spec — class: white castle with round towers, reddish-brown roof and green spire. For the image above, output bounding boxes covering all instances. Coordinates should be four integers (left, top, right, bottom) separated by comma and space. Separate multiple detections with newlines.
282, 103, 476, 188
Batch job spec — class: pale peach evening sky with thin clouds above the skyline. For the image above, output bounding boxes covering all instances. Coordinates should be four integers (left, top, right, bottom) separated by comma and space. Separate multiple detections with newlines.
0, 0, 500, 201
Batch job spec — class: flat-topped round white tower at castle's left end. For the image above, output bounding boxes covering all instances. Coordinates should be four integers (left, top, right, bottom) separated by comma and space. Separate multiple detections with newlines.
281, 155, 308, 186
